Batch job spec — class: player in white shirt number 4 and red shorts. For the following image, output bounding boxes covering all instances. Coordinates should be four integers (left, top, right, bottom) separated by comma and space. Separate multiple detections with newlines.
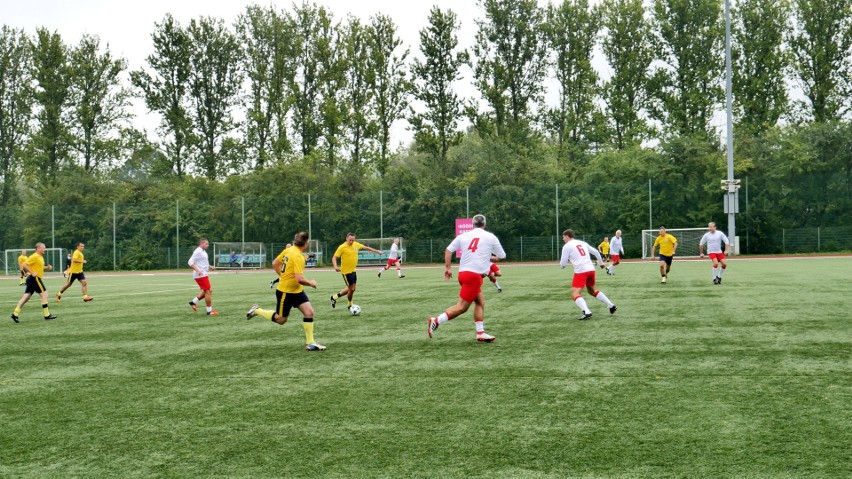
426, 215, 506, 343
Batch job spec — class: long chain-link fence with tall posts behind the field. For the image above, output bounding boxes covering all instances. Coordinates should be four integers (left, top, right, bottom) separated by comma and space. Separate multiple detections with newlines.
3, 177, 852, 271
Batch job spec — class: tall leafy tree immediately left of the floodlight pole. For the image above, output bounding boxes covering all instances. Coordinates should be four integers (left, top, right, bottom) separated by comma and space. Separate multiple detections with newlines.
650, 0, 725, 139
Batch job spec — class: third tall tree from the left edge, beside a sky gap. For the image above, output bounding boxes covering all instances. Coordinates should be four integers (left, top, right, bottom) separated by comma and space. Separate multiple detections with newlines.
71, 35, 130, 172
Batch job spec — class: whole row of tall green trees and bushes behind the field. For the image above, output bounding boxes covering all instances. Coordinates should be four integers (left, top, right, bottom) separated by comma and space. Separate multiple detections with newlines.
0, 0, 852, 262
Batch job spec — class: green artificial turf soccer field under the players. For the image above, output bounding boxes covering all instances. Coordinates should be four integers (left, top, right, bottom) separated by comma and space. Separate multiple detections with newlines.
0, 257, 852, 478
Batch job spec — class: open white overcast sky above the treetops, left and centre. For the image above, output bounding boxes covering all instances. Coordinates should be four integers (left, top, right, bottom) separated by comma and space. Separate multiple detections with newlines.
0, 0, 520, 146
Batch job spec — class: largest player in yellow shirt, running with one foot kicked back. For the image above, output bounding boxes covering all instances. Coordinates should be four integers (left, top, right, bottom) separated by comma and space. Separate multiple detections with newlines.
246, 231, 325, 351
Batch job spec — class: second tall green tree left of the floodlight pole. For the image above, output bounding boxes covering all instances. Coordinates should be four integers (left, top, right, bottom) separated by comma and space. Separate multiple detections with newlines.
599, 0, 654, 150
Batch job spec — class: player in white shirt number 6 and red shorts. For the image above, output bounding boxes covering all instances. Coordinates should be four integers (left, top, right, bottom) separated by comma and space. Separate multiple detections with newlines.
559, 229, 618, 321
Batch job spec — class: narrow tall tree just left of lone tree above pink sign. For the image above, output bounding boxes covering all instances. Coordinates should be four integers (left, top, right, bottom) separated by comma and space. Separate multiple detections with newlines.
368, 15, 411, 176
